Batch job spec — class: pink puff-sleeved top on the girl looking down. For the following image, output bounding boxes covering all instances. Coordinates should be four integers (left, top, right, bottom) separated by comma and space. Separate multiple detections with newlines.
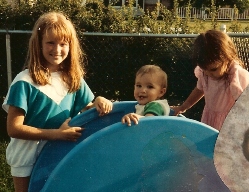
194, 61, 249, 130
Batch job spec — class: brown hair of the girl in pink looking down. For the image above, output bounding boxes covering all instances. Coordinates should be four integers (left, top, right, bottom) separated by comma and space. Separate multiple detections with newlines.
193, 30, 244, 70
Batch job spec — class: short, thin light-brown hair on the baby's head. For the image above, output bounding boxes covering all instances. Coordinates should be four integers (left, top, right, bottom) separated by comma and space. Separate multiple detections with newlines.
136, 65, 168, 89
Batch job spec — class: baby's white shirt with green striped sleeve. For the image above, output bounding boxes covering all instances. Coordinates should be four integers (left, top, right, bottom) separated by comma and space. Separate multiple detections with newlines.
135, 99, 170, 116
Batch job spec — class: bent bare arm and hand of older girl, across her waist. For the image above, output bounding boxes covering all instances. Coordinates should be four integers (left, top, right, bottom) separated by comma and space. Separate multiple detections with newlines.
7, 106, 83, 141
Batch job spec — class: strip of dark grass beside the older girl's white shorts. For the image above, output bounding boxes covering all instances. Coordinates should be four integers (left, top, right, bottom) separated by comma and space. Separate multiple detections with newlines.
0, 141, 14, 192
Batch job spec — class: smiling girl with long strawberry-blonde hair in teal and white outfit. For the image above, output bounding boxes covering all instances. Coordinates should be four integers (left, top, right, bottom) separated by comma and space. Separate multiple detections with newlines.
3, 12, 112, 192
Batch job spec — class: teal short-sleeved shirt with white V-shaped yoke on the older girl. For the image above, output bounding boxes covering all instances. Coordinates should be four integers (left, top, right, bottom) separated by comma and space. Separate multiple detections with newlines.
3, 69, 94, 129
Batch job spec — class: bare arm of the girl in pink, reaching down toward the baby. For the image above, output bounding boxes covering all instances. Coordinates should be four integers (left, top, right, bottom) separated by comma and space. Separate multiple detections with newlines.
171, 87, 204, 115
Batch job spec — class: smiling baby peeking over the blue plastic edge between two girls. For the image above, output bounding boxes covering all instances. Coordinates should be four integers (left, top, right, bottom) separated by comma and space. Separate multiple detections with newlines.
121, 65, 170, 126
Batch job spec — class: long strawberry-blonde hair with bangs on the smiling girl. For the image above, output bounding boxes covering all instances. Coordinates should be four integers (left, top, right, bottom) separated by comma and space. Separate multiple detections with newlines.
25, 12, 84, 92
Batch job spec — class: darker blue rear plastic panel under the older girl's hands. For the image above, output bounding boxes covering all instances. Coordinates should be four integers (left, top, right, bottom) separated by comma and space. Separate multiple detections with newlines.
29, 101, 137, 192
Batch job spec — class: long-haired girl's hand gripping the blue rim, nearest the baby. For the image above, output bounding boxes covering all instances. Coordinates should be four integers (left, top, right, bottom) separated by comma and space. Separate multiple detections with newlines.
93, 96, 113, 116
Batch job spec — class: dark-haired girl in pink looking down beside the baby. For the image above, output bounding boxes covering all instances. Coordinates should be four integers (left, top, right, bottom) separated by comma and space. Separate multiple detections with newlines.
173, 30, 249, 130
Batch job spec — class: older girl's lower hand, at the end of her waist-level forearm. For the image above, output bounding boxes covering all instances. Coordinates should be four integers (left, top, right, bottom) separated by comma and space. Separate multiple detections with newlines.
55, 118, 84, 141
